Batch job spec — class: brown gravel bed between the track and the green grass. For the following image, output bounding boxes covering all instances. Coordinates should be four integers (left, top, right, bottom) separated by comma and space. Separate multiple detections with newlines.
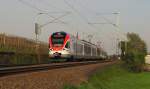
0, 63, 116, 89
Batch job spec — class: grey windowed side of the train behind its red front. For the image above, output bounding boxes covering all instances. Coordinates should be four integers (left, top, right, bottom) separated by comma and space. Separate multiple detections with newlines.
70, 37, 104, 60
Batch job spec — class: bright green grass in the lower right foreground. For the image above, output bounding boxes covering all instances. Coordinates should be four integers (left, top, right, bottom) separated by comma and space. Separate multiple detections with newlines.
64, 64, 150, 89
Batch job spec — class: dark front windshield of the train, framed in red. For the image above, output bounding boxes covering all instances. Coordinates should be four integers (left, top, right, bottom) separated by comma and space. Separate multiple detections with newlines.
52, 33, 66, 47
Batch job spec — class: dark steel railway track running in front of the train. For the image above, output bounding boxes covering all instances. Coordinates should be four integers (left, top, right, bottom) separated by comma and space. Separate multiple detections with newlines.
0, 60, 110, 76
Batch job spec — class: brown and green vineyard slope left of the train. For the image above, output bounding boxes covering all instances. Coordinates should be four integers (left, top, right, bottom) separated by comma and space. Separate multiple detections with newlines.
0, 34, 48, 65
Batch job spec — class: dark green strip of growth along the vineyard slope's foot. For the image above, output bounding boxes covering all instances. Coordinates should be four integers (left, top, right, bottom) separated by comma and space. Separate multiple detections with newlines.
0, 54, 50, 65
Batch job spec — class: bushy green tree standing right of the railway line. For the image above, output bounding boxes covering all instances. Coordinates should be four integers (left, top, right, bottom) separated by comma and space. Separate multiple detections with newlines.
120, 33, 147, 72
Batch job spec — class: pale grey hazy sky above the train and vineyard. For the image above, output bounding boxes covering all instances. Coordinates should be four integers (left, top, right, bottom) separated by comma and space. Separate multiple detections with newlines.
0, 0, 150, 54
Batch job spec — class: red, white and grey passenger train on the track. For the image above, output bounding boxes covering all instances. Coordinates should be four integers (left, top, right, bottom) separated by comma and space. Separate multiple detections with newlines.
49, 31, 107, 60
